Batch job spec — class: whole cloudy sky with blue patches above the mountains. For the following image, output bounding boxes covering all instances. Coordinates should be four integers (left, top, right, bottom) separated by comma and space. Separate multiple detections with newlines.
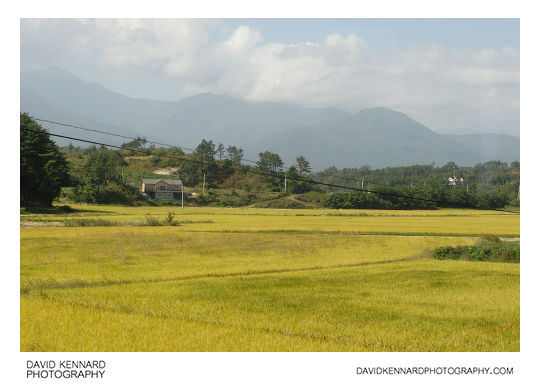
20, 19, 520, 136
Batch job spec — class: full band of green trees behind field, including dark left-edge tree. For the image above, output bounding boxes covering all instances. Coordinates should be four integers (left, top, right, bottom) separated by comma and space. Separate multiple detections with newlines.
21, 114, 519, 209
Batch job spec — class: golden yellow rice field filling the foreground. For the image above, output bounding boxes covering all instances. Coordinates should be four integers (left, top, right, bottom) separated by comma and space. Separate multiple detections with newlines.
20, 205, 520, 351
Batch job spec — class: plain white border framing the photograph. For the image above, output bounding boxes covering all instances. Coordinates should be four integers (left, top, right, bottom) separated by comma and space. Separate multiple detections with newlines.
4, 0, 540, 384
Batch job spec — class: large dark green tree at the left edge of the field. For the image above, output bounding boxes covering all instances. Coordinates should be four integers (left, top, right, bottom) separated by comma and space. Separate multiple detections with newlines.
20, 113, 68, 206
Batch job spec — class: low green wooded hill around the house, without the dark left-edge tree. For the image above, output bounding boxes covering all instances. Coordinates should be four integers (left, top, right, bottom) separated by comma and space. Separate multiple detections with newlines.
59, 140, 519, 209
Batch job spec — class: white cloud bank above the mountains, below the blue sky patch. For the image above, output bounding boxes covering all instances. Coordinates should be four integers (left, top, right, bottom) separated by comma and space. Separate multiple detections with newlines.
21, 19, 519, 134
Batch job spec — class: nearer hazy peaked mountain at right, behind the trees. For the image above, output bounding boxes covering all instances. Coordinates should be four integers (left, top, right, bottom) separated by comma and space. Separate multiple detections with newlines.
248, 108, 519, 170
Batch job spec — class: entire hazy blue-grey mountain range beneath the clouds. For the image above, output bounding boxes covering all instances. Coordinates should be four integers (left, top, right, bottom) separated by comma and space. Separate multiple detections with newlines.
21, 69, 519, 170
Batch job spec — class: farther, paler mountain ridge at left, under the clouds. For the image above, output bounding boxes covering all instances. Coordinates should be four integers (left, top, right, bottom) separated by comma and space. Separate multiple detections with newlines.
21, 69, 347, 147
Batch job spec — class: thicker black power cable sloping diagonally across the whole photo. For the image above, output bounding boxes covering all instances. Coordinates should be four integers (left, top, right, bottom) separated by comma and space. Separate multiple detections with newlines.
21, 127, 515, 214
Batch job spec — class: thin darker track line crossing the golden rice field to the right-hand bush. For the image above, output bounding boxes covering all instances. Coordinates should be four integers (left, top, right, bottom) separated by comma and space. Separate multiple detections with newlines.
25, 254, 427, 295
